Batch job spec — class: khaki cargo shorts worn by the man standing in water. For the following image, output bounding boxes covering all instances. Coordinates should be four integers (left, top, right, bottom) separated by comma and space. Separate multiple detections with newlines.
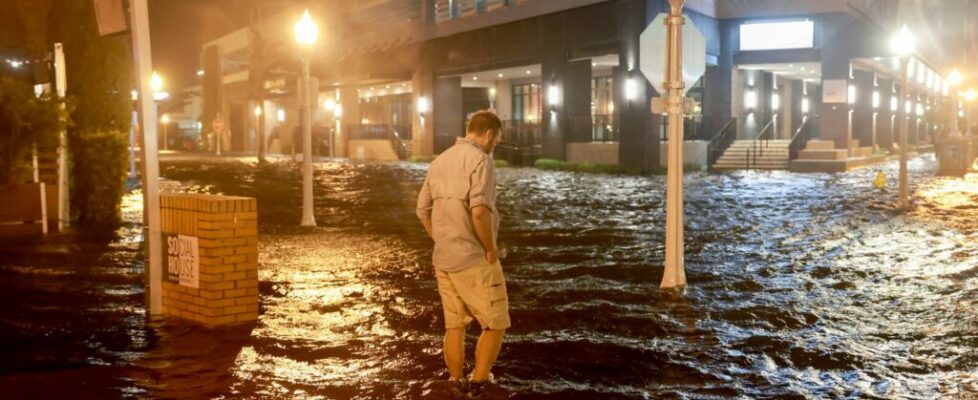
435, 261, 509, 330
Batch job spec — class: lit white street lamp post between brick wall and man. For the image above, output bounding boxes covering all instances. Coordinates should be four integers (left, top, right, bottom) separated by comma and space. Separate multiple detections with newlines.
295, 10, 319, 226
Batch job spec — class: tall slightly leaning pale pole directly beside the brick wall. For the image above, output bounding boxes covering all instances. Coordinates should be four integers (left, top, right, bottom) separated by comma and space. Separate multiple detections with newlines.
129, 0, 163, 315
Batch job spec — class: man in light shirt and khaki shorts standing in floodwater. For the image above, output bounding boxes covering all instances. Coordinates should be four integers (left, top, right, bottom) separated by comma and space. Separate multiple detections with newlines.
417, 111, 510, 398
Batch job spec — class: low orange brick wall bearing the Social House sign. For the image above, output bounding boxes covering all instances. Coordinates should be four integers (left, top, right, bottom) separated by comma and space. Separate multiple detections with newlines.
160, 194, 258, 327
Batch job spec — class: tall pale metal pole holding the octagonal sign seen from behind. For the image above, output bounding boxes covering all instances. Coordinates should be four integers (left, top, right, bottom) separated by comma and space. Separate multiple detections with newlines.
659, 0, 686, 289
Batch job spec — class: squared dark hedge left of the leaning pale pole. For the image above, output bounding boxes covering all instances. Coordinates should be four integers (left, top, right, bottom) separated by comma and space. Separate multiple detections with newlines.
68, 130, 129, 229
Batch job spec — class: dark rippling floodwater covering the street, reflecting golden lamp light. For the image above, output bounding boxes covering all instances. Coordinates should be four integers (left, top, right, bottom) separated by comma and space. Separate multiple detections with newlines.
0, 155, 978, 399
